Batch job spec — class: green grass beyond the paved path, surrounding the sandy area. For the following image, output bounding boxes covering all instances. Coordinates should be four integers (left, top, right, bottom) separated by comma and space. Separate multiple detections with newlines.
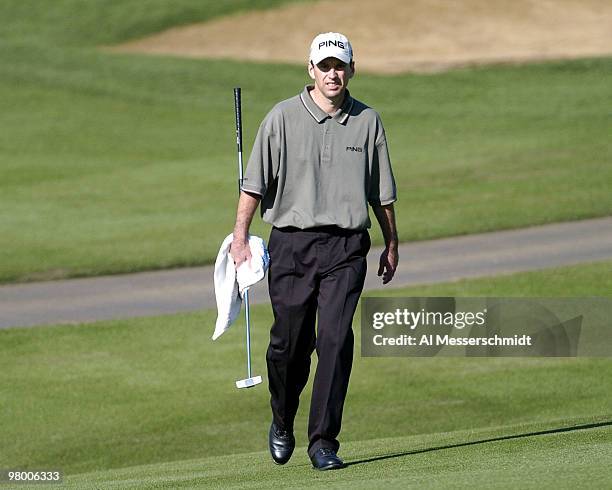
0, 0, 612, 282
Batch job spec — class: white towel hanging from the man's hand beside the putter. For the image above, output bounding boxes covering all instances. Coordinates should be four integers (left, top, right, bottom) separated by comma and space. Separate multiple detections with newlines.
212, 234, 270, 340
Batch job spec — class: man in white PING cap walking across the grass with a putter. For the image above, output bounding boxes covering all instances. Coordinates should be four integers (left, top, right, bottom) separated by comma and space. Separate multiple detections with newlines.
230, 32, 398, 470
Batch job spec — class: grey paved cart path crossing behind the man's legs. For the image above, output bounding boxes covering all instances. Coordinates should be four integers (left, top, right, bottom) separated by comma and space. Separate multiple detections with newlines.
0, 217, 612, 328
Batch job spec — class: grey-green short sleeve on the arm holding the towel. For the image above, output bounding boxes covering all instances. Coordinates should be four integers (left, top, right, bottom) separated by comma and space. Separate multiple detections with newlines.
241, 116, 280, 197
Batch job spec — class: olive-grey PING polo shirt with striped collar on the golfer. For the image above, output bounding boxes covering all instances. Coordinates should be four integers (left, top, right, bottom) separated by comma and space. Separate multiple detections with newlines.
242, 86, 396, 230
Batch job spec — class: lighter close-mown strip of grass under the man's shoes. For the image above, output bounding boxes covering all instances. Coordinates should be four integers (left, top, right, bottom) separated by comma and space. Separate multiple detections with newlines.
59, 420, 612, 489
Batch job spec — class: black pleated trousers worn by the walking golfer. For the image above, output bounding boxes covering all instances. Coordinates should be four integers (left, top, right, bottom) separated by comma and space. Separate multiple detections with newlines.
266, 226, 370, 455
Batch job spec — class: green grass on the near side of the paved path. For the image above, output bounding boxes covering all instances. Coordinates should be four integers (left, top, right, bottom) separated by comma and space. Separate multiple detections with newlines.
0, 262, 612, 488
